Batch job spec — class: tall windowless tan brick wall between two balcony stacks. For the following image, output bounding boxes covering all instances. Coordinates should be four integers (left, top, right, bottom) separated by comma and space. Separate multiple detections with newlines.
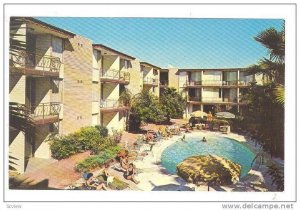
61, 36, 93, 134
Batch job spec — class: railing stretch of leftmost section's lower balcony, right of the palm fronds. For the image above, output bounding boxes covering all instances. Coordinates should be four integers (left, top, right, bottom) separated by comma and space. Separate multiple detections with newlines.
30, 102, 61, 119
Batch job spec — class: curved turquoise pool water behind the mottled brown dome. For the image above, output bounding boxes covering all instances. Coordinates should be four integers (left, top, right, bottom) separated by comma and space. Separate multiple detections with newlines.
161, 134, 255, 177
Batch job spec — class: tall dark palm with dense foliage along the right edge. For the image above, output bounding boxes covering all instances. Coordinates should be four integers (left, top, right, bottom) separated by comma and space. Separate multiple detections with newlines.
245, 24, 285, 157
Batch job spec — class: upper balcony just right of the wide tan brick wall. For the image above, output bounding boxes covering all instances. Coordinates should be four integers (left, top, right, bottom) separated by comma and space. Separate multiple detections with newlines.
100, 69, 130, 84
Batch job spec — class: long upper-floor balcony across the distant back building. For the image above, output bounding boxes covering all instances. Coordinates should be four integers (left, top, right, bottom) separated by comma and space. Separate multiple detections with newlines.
184, 80, 251, 88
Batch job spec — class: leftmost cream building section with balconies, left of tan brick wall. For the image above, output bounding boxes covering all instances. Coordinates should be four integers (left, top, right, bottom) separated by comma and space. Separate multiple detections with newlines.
9, 18, 75, 172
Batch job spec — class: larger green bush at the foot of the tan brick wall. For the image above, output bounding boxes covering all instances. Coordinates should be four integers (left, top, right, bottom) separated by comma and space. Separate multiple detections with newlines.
50, 127, 116, 160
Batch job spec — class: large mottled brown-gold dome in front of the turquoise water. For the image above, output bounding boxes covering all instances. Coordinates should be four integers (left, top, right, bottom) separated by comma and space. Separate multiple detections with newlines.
177, 155, 241, 186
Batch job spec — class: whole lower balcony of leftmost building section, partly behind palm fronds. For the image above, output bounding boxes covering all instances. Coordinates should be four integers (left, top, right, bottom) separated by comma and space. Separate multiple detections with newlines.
9, 102, 61, 130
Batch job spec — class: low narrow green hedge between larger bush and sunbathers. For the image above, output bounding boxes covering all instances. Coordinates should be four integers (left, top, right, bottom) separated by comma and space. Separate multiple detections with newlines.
75, 146, 121, 172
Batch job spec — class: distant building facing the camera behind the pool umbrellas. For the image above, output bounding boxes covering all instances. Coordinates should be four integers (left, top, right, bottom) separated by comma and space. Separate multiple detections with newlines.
172, 68, 255, 117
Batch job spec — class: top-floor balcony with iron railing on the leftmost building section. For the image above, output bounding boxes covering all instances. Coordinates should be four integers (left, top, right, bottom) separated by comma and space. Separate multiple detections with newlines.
9, 50, 62, 78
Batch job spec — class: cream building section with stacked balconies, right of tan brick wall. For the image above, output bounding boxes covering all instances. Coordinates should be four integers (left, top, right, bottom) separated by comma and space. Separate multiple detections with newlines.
93, 44, 135, 132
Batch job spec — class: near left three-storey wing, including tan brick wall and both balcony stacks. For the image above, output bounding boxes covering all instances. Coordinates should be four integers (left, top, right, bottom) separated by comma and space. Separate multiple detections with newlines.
9, 17, 140, 172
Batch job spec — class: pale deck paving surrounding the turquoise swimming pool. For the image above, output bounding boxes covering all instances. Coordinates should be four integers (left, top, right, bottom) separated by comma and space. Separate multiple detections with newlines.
134, 131, 283, 192
